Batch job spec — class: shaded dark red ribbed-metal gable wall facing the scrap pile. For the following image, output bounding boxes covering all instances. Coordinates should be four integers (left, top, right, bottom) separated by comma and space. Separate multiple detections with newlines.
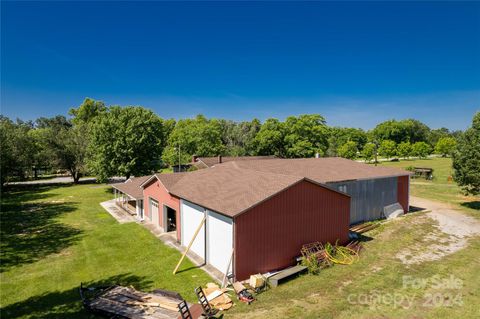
234, 181, 350, 280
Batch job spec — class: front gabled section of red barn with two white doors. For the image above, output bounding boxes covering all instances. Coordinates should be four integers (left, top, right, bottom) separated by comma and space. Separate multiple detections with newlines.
171, 166, 350, 280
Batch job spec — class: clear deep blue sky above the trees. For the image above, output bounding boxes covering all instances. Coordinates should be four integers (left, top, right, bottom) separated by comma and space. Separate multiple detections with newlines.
1, 2, 480, 129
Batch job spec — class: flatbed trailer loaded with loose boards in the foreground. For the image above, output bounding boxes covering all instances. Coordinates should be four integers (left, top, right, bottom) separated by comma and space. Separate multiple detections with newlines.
80, 285, 183, 319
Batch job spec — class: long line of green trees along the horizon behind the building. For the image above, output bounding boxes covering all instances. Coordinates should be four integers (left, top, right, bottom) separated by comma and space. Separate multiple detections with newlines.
0, 98, 478, 195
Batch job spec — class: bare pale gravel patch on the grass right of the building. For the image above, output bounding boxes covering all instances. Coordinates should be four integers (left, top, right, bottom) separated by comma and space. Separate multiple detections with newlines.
396, 197, 480, 265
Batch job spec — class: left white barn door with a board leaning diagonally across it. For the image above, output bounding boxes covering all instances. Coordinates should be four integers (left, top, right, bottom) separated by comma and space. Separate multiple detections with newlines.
180, 200, 205, 258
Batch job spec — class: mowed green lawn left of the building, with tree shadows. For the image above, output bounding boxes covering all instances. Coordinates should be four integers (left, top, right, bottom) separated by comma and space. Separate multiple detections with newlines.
0, 184, 212, 318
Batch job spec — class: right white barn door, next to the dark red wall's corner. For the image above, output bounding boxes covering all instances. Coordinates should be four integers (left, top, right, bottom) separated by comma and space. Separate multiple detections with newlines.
207, 211, 233, 273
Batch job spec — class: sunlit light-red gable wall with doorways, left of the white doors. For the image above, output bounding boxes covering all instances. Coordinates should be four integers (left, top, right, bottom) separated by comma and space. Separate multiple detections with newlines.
143, 179, 181, 240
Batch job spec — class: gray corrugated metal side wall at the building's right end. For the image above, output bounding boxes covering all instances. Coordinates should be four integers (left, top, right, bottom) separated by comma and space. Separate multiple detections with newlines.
327, 177, 398, 224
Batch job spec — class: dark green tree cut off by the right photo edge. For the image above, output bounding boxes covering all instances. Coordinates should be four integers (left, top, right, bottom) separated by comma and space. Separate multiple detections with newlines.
453, 112, 480, 195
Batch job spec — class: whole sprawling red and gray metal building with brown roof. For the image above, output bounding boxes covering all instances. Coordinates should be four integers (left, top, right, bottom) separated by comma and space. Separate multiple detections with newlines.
111, 158, 410, 280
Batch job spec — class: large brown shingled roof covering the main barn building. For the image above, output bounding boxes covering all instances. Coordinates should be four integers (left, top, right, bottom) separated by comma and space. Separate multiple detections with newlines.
167, 158, 410, 217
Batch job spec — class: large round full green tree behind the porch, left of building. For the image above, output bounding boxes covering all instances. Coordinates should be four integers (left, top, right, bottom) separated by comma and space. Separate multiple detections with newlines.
88, 106, 165, 181
